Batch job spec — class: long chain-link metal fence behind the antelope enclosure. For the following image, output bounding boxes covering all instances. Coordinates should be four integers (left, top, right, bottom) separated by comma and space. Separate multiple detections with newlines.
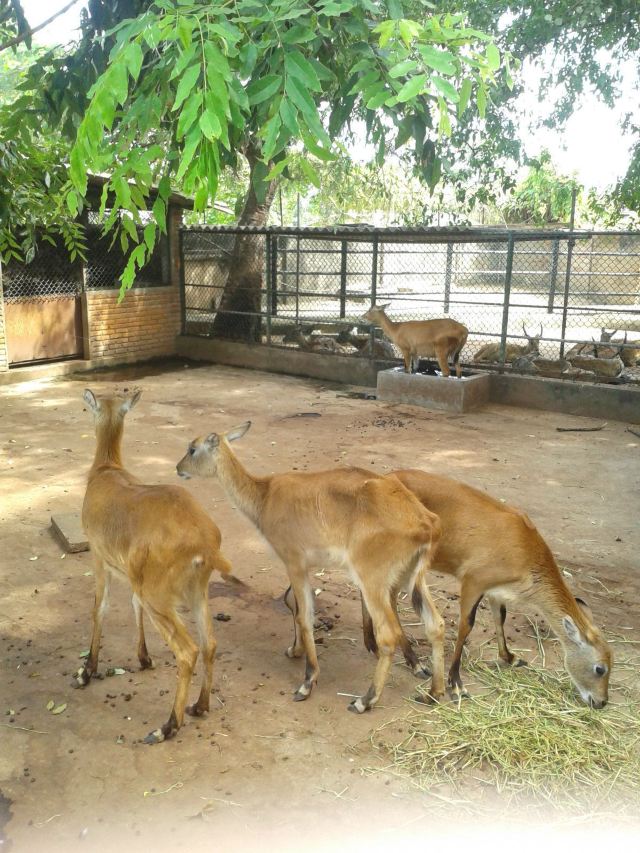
181, 226, 640, 378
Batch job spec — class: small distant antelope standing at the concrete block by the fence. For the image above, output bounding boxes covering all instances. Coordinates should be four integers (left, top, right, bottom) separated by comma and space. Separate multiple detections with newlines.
363, 303, 469, 379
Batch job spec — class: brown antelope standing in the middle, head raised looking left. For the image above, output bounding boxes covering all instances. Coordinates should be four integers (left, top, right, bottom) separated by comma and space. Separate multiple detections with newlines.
176, 421, 444, 714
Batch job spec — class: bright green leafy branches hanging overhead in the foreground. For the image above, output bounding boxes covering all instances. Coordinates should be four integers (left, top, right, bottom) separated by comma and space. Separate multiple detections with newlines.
2, 0, 508, 285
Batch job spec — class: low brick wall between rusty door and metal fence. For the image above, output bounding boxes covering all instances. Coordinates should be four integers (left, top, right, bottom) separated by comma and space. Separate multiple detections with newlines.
83, 286, 180, 364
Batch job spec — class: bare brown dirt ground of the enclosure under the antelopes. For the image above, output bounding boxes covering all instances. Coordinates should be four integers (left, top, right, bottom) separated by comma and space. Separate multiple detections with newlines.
0, 356, 640, 851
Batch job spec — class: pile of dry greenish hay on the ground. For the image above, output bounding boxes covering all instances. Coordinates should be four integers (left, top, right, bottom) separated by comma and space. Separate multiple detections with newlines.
373, 661, 640, 817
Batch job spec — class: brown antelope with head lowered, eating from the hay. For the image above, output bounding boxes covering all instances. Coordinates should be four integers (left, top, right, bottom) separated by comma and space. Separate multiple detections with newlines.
363, 470, 612, 708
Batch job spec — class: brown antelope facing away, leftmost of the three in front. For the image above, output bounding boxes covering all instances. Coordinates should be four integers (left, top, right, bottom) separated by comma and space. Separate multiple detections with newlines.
72, 389, 234, 744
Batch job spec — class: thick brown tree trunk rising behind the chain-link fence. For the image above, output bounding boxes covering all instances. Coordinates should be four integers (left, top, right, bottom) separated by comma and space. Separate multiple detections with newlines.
211, 152, 277, 342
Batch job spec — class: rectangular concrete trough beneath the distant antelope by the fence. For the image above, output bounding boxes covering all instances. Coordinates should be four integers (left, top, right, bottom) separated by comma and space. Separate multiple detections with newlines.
378, 368, 491, 413
